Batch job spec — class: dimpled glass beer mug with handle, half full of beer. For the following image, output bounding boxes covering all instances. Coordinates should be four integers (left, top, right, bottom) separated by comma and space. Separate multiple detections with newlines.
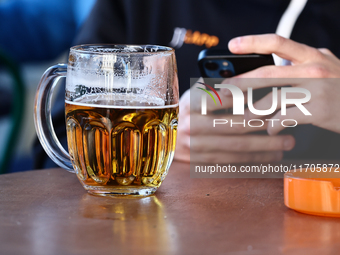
34, 45, 179, 196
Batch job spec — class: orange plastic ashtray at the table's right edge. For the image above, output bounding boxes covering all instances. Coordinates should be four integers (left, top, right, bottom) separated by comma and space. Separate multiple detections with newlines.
284, 168, 340, 217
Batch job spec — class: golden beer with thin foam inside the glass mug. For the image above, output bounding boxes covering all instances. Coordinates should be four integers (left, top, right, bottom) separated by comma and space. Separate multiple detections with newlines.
65, 94, 178, 195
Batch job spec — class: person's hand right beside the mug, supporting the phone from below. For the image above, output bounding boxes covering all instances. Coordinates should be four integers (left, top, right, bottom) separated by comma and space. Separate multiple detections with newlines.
175, 79, 295, 163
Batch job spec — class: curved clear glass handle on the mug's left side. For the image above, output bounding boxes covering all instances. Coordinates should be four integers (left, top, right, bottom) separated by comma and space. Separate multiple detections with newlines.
34, 64, 74, 173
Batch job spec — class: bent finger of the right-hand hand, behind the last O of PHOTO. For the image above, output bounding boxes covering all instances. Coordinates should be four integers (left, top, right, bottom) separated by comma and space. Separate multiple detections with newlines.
267, 104, 312, 135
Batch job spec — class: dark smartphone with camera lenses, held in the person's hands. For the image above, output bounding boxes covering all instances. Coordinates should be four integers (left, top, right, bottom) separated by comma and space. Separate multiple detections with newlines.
198, 49, 275, 102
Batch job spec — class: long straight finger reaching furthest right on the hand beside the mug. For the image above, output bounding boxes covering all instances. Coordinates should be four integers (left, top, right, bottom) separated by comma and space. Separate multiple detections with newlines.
190, 135, 295, 153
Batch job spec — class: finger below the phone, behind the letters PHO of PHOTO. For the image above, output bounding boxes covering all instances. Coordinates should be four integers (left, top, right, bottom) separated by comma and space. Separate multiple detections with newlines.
190, 113, 268, 135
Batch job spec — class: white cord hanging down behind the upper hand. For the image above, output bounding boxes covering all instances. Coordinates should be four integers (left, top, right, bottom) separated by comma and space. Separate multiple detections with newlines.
273, 0, 307, 65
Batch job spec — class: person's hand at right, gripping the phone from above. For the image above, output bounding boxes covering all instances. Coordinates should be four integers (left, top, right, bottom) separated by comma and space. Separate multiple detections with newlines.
226, 34, 340, 135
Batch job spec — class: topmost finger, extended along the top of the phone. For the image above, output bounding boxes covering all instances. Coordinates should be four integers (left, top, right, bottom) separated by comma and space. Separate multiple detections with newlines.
228, 34, 320, 63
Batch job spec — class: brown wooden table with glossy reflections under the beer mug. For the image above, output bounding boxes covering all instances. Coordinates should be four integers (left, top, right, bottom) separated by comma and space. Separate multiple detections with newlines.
0, 162, 340, 255
